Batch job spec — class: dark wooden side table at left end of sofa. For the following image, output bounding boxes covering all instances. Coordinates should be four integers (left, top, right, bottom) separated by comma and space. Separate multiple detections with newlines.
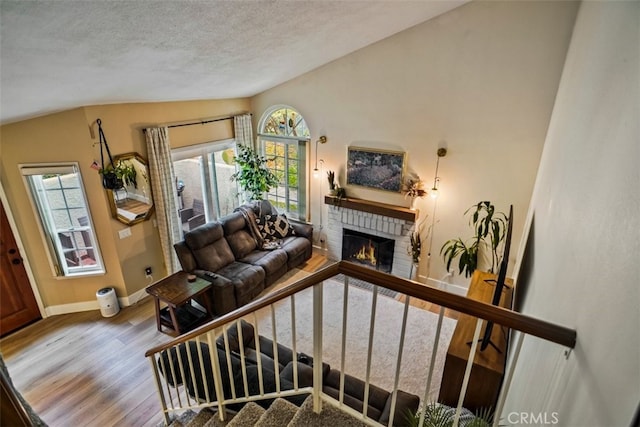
146, 271, 213, 336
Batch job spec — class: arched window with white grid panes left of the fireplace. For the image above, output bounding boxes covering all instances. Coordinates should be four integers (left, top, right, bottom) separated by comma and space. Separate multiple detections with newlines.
258, 105, 310, 220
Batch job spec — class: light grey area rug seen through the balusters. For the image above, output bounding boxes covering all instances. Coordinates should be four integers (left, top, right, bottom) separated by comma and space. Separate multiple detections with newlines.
247, 280, 456, 400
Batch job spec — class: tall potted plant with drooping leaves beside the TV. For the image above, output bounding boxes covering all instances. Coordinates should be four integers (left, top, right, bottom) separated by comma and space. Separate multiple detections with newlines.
440, 201, 507, 277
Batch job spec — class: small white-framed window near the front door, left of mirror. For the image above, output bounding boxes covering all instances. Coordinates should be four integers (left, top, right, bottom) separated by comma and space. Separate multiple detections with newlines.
20, 162, 105, 277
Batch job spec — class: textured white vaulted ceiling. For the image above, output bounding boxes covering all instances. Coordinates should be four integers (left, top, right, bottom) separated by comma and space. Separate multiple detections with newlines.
0, 0, 468, 123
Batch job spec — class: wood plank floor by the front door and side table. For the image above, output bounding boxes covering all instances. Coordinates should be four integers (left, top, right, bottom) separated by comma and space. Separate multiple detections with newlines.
0, 254, 458, 427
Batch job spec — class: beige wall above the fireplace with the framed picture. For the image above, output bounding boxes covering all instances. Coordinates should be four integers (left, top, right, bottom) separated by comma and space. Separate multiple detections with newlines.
252, 2, 577, 285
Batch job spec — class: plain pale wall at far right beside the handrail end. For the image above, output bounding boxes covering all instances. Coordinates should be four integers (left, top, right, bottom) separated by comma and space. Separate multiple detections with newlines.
503, 2, 640, 426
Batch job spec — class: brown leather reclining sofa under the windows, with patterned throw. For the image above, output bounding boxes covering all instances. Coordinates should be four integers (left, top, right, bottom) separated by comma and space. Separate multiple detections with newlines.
174, 202, 313, 316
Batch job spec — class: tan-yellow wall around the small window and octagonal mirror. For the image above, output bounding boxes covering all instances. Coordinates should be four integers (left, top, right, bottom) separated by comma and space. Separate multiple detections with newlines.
0, 99, 250, 312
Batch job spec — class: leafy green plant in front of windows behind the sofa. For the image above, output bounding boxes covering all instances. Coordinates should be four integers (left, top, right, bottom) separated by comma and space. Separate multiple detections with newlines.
231, 145, 279, 201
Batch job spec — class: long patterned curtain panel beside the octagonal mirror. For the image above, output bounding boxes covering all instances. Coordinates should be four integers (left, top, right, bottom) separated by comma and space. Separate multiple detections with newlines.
146, 127, 182, 274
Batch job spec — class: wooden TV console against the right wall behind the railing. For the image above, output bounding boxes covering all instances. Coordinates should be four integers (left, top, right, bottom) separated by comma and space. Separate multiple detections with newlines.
438, 270, 513, 411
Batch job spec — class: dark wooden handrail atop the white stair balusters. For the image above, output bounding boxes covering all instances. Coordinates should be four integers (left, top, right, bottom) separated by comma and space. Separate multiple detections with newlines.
145, 261, 577, 357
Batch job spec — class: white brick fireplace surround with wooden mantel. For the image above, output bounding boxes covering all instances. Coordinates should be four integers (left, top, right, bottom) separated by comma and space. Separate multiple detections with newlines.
325, 196, 417, 278
